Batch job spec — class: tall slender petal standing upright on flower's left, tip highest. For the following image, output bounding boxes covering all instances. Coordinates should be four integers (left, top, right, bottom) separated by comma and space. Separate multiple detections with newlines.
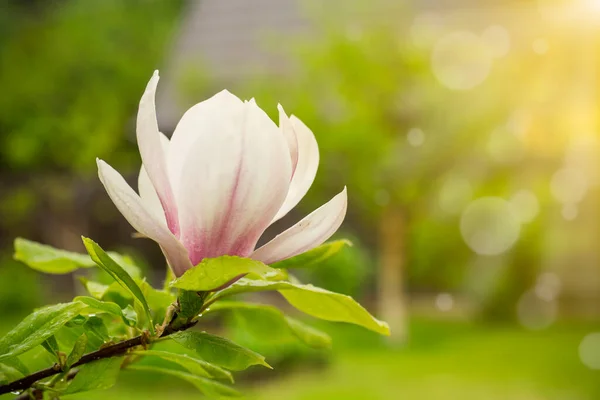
136, 71, 179, 235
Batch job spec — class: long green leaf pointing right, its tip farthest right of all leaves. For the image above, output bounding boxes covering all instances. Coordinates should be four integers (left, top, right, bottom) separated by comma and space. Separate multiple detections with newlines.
214, 279, 390, 335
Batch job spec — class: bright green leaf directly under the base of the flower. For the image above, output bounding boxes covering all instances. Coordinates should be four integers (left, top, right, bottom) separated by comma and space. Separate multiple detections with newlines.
171, 256, 285, 292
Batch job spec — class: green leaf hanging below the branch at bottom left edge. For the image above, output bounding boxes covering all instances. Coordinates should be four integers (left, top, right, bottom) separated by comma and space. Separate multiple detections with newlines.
64, 357, 123, 394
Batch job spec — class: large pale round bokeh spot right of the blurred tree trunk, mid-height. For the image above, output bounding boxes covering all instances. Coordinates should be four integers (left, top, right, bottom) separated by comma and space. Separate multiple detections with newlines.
460, 197, 521, 255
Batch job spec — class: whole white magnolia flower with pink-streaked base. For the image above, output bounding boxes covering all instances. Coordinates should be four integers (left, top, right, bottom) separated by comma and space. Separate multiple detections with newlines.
97, 72, 347, 276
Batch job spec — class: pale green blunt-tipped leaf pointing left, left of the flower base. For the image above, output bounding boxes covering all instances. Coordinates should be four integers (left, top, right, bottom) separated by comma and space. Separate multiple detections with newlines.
14, 238, 94, 274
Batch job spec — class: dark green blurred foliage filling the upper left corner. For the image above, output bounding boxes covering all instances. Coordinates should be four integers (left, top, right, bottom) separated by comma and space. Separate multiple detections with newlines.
0, 0, 181, 173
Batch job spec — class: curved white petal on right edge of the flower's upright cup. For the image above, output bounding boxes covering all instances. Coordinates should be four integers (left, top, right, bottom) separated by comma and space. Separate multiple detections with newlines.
273, 115, 319, 222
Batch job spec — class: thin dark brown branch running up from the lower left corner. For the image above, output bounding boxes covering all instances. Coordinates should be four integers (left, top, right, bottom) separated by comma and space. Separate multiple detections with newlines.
0, 318, 197, 398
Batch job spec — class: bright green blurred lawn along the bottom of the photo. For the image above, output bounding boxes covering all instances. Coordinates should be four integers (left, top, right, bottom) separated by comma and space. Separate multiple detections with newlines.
54, 320, 600, 400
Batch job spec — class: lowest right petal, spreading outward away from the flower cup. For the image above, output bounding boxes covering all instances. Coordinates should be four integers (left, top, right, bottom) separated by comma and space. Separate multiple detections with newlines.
250, 187, 348, 264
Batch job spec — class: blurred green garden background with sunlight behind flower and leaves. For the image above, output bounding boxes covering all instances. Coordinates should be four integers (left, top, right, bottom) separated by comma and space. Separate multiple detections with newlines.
0, 0, 600, 400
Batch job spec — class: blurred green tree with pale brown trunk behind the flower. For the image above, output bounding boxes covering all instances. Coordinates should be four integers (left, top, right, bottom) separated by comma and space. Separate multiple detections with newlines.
238, 3, 502, 342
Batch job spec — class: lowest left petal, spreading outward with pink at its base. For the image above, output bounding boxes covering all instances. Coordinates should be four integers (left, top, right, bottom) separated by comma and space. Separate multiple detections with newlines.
97, 160, 192, 276
